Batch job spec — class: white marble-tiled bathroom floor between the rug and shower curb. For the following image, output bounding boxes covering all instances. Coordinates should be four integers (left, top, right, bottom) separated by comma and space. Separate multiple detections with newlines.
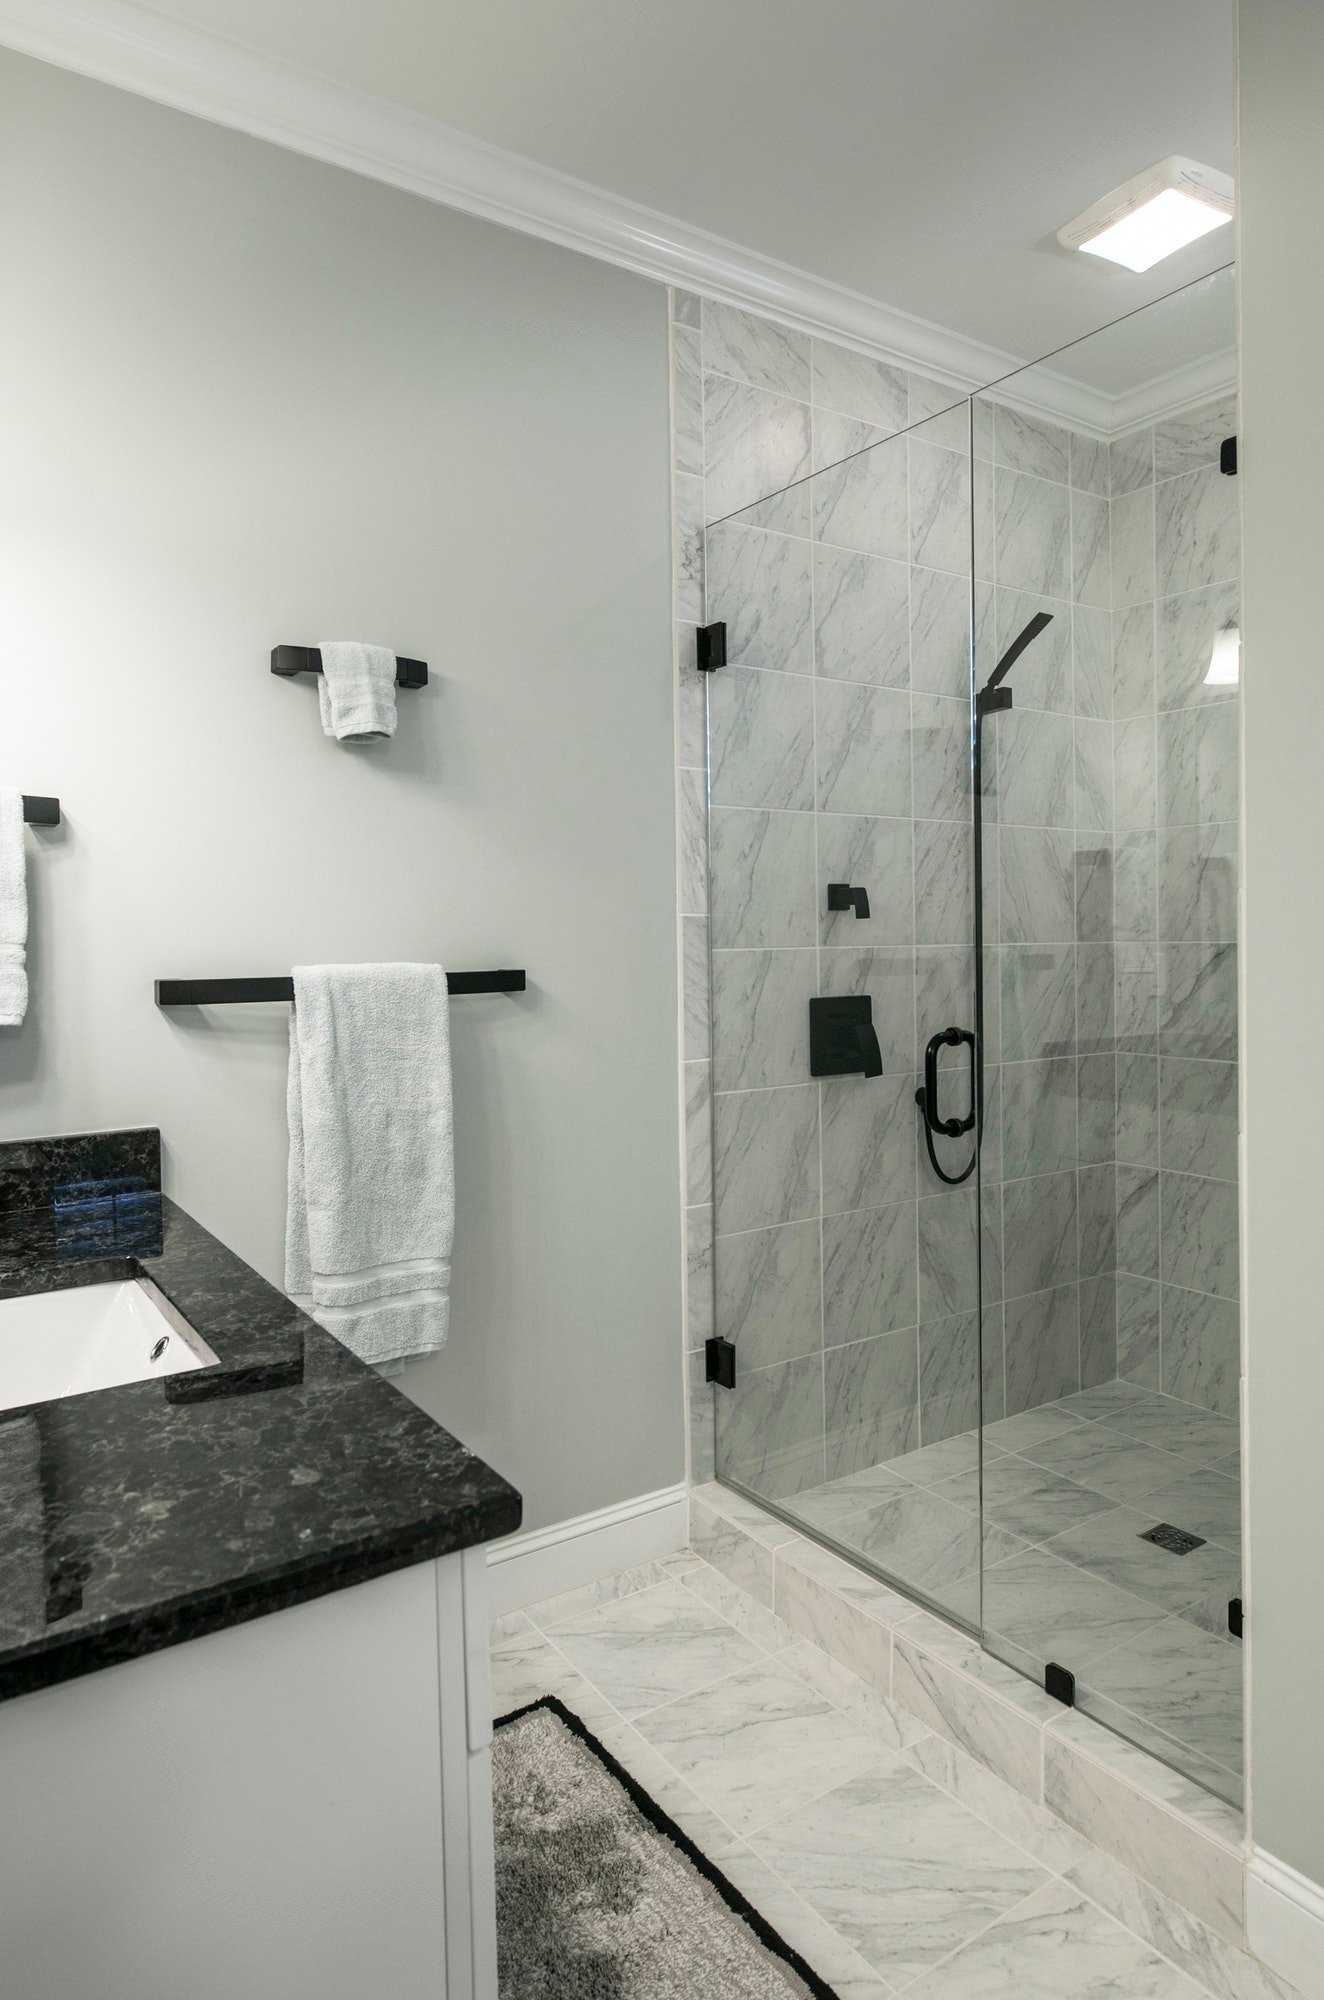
492, 1544, 1276, 2000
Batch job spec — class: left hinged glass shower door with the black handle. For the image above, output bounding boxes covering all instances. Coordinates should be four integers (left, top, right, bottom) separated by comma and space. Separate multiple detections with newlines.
704, 382, 996, 1626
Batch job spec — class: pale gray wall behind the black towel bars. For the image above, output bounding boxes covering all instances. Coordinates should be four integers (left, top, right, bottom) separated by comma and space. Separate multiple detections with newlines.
0, 54, 682, 1526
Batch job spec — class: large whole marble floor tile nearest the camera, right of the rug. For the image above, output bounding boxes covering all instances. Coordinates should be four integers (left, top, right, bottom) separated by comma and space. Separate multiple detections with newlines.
750, 1758, 1044, 1984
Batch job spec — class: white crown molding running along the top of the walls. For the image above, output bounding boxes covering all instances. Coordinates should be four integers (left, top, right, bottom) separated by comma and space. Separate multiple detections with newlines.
0, 0, 1236, 438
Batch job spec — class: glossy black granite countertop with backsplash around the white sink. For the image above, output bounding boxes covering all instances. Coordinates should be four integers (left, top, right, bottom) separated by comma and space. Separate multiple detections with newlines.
0, 1130, 520, 1700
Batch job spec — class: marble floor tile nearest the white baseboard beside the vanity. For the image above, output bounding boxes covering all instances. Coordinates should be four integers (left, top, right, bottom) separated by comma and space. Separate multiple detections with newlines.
548, 1582, 764, 1716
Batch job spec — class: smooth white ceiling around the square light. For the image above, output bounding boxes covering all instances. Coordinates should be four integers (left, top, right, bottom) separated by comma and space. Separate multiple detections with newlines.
130, 0, 1234, 358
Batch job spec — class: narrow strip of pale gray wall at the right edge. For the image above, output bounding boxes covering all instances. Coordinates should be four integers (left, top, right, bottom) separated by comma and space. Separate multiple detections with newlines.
1240, 0, 1324, 1882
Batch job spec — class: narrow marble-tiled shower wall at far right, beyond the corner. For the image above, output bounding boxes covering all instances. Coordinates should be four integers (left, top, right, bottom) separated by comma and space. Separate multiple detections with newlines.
1110, 396, 1240, 1416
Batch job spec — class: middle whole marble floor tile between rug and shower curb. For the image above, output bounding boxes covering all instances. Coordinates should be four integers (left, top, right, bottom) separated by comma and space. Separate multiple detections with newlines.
638, 1658, 886, 1834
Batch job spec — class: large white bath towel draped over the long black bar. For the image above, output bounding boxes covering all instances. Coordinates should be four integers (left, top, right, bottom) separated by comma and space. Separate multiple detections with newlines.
286, 966, 456, 1362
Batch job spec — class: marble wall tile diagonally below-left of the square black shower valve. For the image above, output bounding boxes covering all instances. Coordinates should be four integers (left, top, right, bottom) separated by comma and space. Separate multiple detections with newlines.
714, 1084, 818, 1236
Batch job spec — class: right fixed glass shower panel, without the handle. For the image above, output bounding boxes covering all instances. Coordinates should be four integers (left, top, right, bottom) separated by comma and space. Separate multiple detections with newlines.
972, 258, 1242, 1800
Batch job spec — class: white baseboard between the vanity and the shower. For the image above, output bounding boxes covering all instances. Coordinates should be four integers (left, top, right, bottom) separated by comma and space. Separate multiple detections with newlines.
488, 1482, 690, 1618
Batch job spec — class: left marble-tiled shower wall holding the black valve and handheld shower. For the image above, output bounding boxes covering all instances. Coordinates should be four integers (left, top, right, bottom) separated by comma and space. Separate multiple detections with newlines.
674, 294, 1234, 1496
